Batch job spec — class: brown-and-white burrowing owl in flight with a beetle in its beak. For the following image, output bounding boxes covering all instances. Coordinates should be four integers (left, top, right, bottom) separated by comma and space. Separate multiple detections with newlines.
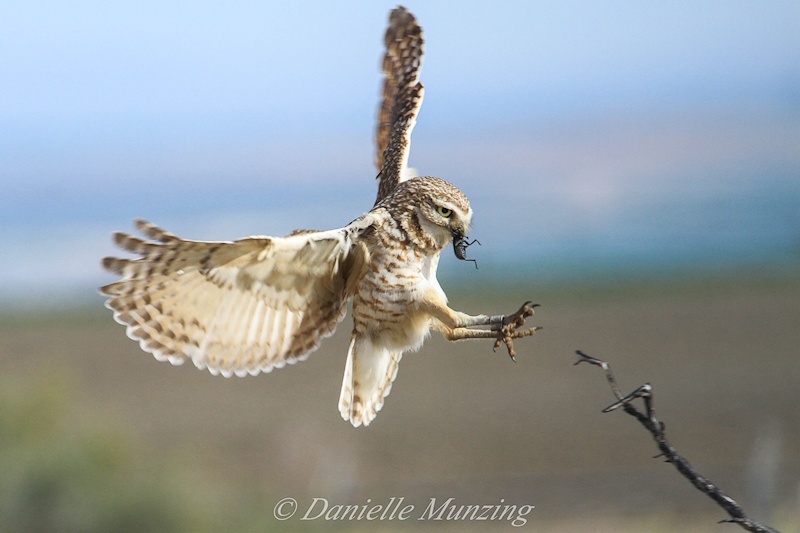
100, 7, 536, 426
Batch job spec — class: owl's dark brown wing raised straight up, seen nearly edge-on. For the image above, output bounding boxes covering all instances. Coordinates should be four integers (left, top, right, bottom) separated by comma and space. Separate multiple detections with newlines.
375, 6, 424, 204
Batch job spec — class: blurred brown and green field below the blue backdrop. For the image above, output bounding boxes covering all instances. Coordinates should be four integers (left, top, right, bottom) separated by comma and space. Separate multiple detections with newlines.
0, 273, 800, 531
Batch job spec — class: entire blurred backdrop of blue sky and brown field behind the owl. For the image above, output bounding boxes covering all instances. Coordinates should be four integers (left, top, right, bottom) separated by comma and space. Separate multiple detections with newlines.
0, 0, 800, 531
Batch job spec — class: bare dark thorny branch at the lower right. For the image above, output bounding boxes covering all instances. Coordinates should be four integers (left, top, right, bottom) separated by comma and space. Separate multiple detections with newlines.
575, 350, 777, 533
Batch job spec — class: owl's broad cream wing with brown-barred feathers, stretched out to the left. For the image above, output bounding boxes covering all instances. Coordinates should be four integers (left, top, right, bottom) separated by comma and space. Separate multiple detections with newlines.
100, 214, 371, 377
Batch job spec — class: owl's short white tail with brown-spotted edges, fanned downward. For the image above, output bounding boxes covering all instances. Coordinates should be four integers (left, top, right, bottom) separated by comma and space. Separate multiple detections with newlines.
339, 334, 403, 427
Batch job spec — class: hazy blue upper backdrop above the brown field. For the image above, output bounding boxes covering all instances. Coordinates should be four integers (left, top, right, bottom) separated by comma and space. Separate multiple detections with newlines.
0, 1, 800, 302
